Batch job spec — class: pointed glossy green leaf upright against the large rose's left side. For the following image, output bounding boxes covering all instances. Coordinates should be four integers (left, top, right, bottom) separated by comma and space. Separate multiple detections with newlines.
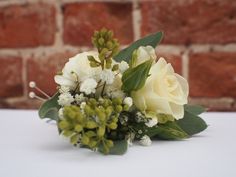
121, 60, 153, 93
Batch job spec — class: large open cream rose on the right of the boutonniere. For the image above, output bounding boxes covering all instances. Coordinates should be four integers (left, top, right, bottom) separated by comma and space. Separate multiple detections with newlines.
131, 58, 189, 119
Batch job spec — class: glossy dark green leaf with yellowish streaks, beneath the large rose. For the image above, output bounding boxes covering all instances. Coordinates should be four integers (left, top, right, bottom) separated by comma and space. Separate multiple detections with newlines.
147, 121, 188, 140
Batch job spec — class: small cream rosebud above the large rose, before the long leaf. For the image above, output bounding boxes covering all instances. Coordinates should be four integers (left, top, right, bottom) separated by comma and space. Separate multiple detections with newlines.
134, 46, 157, 66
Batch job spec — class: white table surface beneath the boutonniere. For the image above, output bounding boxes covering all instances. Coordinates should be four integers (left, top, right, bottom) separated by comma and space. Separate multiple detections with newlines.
0, 110, 236, 177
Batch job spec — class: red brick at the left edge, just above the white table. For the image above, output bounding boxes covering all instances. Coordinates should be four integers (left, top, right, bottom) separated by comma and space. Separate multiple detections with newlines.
0, 56, 23, 98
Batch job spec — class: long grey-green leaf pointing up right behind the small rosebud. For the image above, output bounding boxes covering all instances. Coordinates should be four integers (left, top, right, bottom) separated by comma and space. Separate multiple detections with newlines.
114, 32, 163, 63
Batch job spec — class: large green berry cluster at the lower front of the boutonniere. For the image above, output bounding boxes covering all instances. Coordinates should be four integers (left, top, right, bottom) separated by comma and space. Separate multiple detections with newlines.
58, 98, 129, 154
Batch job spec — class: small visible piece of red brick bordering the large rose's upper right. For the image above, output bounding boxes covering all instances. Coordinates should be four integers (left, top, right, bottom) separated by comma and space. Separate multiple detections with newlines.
157, 53, 182, 75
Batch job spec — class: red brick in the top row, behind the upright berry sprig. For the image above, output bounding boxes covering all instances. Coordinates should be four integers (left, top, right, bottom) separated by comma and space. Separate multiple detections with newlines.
63, 2, 133, 46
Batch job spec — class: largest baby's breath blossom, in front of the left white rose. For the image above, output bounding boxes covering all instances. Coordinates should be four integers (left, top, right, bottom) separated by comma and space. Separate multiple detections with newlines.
80, 78, 97, 95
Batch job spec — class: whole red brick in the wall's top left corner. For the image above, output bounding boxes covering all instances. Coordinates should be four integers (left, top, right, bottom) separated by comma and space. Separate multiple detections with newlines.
0, 3, 55, 48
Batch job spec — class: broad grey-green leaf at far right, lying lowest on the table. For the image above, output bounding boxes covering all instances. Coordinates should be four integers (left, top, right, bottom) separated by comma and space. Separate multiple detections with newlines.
176, 110, 207, 136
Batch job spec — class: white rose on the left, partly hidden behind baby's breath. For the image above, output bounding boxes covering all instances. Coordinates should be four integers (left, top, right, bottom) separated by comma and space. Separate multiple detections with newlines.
54, 51, 101, 90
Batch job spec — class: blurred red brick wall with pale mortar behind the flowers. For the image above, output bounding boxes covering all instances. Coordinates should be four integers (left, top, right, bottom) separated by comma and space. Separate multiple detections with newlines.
0, 0, 236, 111
